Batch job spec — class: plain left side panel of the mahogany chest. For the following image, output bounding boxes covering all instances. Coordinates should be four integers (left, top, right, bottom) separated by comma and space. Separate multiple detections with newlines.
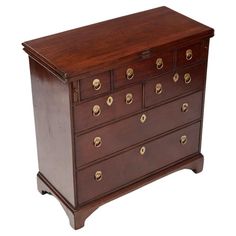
30, 59, 76, 206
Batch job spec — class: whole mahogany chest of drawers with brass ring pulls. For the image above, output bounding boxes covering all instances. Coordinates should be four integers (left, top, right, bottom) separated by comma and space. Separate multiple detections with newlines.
23, 7, 214, 229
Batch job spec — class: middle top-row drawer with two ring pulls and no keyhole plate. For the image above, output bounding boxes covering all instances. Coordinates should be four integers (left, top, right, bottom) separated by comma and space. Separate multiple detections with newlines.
114, 51, 173, 88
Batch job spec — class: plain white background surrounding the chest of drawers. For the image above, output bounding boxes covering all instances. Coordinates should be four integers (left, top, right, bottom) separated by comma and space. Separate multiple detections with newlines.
0, 0, 236, 236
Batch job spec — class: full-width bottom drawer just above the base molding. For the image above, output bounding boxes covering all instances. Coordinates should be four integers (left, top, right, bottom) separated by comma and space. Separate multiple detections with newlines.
77, 123, 200, 204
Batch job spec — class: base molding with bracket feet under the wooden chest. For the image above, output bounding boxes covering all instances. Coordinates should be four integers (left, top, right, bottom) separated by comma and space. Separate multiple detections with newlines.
37, 154, 204, 229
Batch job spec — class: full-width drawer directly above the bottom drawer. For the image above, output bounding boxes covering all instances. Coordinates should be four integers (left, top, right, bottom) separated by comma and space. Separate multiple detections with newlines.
75, 92, 202, 167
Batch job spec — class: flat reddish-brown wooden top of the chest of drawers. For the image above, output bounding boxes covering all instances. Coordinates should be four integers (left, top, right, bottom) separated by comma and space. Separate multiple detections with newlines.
23, 7, 214, 80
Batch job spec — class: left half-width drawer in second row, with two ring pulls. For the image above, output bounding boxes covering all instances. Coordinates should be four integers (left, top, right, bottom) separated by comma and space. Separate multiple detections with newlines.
74, 85, 142, 132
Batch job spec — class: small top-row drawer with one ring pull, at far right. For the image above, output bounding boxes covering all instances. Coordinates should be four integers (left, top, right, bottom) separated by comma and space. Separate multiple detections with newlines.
177, 42, 207, 67
